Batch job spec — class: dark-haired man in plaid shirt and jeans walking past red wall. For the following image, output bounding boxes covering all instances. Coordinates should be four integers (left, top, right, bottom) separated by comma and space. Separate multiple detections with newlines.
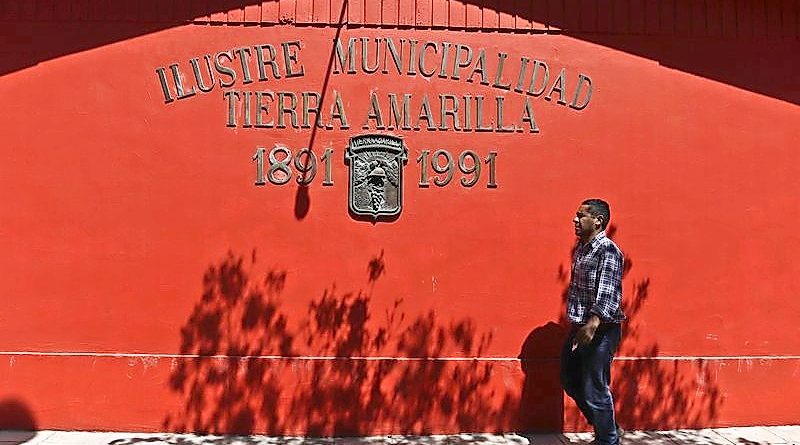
561, 199, 625, 445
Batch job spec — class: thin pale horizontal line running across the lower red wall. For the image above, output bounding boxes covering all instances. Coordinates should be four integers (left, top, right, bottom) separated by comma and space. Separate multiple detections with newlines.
0, 351, 800, 362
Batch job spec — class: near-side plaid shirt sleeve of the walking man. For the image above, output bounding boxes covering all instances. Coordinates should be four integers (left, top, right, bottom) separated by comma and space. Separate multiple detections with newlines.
589, 244, 625, 322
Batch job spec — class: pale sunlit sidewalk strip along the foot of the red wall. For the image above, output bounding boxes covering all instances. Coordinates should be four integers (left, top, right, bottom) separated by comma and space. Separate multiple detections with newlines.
0, 425, 800, 445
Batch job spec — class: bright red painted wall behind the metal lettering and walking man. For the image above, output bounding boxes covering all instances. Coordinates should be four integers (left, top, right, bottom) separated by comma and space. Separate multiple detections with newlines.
0, 0, 800, 434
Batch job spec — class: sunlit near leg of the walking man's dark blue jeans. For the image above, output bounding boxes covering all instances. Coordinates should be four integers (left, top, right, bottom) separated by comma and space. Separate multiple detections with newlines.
576, 325, 620, 445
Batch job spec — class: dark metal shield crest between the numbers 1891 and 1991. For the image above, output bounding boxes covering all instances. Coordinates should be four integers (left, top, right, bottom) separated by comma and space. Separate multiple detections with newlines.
345, 134, 408, 219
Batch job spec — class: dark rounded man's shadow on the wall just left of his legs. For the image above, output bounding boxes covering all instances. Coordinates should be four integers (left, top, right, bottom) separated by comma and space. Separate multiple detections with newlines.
519, 321, 567, 433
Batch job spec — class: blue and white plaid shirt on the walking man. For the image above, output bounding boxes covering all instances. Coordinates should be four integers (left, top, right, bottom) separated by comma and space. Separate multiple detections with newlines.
567, 232, 625, 324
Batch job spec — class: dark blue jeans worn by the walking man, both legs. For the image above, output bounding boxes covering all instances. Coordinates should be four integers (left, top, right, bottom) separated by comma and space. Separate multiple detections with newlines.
561, 323, 620, 445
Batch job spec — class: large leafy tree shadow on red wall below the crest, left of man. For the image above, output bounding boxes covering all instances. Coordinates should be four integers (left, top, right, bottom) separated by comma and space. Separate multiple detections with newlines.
123, 252, 515, 443
